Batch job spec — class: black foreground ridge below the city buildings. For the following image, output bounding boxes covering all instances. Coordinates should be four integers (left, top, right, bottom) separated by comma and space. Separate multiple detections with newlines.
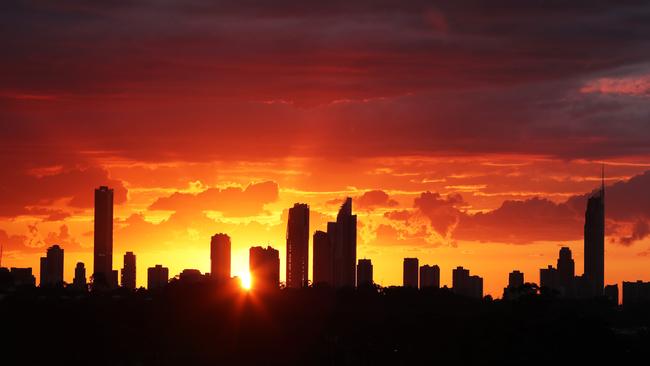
0, 282, 650, 365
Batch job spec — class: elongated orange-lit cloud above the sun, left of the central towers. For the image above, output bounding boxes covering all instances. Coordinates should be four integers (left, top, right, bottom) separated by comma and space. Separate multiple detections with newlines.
149, 181, 278, 216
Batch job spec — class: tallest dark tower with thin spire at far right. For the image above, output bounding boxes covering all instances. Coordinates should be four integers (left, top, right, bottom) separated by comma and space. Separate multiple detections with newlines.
584, 173, 605, 296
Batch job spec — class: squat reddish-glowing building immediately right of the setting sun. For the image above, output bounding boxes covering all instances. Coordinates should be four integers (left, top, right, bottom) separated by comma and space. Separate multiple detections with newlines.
248, 247, 280, 290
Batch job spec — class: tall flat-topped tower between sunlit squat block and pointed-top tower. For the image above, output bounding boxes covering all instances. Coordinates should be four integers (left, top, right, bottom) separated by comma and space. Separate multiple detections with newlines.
287, 203, 309, 288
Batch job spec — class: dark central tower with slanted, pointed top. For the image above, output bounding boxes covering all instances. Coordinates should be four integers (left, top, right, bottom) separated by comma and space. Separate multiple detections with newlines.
327, 197, 357, 288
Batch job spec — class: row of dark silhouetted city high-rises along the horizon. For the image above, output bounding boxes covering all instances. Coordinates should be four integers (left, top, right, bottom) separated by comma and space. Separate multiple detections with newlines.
2, 176, 632, 302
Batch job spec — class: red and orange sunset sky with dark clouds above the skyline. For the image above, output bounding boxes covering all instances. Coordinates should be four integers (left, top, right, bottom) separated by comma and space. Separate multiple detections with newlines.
0, 0, 650, 297
